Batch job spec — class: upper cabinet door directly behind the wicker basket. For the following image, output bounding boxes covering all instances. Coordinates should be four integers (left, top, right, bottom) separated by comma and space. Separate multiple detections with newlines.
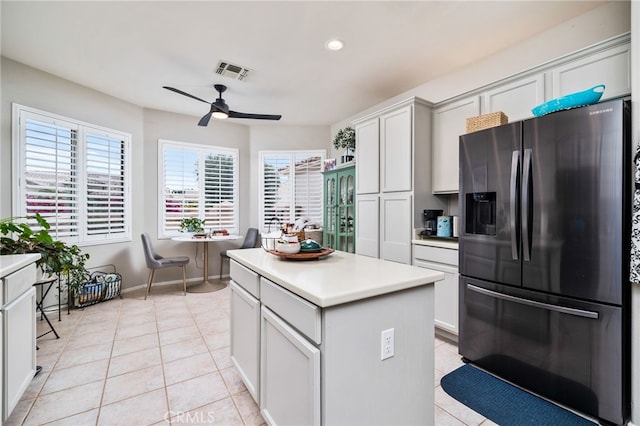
482, 74, 544, 122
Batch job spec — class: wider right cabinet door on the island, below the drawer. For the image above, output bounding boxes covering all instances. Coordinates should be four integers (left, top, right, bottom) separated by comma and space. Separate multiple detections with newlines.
260, 306, 320, 425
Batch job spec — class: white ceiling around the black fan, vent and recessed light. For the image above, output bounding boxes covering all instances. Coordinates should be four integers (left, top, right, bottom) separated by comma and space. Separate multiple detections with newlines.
1, 0, 605, 125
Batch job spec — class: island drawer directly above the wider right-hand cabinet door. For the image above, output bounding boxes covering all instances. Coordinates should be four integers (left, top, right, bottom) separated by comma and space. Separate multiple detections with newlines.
260, 278, 321, 344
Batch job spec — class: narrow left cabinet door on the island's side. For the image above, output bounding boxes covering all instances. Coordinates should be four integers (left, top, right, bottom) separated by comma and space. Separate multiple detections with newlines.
230, 281, 260, 402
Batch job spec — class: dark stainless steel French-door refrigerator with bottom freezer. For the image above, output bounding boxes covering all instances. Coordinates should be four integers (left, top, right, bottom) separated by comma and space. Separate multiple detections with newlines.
459, 100, 632, 424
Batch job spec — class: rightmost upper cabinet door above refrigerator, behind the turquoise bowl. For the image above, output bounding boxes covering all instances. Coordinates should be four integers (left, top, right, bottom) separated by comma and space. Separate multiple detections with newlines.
552, 43, 631, 100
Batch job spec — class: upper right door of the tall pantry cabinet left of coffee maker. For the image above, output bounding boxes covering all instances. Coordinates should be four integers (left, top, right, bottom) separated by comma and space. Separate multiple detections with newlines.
380, 105, 413, 192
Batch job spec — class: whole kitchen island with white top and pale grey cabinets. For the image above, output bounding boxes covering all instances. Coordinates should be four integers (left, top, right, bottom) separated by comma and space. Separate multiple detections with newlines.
228, 248, 444, 425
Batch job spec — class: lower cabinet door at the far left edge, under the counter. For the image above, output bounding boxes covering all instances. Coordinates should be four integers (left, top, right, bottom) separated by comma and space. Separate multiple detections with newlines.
2, 286, 36, 420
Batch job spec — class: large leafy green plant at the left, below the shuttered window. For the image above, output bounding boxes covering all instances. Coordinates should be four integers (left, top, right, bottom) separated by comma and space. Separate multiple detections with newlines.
0, 213, 89, 293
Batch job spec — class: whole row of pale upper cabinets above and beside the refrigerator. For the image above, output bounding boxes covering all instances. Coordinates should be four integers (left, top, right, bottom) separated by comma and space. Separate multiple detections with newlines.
432, 34, 631, 194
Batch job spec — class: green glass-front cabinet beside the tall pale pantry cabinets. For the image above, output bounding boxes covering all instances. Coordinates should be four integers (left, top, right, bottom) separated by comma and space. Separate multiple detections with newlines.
322, 164, 356, 253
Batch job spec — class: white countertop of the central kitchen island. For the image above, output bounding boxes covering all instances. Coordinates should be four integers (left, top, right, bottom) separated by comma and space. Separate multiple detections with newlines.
227, 248, 444, 308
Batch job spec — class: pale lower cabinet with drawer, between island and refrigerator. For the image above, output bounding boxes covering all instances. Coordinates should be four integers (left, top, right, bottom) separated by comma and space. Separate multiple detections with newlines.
413, 244, 458, 337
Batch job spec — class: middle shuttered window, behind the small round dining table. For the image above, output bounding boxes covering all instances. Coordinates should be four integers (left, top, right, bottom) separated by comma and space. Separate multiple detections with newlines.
158, 140, 240, 237
